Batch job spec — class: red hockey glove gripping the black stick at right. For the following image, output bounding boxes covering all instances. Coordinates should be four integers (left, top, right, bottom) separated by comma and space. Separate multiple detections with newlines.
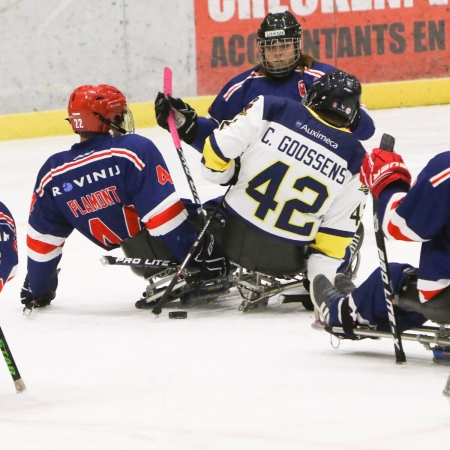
359, 148, 411, 199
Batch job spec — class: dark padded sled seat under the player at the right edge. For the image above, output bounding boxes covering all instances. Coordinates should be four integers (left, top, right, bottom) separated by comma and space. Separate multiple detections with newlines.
398, 288, 450, 323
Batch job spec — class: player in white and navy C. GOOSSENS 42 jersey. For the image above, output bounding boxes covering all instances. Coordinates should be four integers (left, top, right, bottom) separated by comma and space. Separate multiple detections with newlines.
197, 70, 367, 296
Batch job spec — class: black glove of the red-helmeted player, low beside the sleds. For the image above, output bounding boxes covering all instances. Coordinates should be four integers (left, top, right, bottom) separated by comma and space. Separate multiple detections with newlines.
186, 231, 230, 284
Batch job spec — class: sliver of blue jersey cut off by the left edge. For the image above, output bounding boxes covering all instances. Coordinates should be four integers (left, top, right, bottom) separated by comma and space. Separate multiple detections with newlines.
0, 202, 19, 292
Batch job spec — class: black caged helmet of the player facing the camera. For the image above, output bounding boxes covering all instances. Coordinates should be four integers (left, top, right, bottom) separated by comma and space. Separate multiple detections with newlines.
258, 11, 302, 77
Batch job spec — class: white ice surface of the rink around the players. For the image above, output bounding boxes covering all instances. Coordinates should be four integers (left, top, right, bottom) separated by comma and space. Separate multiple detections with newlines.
0, 105, 450, 450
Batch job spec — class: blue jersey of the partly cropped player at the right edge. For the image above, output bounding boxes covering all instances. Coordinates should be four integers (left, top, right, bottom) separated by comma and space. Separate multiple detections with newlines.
380, 151, 450, 301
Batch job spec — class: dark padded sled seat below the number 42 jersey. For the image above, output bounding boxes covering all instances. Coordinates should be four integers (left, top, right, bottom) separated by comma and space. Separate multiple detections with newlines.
220, 214, 307, 277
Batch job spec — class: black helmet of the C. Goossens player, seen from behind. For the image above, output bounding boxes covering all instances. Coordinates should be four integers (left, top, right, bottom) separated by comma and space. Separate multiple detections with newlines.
304, 70, 361, 127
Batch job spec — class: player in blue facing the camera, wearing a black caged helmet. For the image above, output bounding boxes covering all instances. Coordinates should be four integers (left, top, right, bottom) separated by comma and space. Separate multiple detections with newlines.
155, 11, 375, 151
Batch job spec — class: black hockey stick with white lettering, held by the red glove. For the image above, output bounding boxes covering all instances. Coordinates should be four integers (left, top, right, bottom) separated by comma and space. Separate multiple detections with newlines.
372, 133, 406, 364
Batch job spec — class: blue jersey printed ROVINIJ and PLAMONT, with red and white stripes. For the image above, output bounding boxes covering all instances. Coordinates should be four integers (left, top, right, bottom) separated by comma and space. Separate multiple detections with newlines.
27, 134, 197, 296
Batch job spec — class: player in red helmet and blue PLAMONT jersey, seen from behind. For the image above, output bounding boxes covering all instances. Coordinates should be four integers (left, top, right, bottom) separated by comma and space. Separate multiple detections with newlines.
21, 84, 228, 309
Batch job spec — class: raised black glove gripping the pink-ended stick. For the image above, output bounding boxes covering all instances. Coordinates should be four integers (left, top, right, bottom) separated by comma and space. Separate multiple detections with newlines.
155, 92, 198, 144
